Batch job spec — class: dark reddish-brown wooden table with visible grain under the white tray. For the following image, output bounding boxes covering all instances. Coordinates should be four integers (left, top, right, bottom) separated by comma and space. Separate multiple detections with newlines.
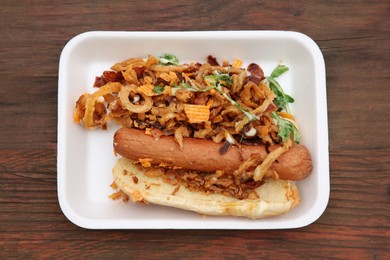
0, 0, 390, 259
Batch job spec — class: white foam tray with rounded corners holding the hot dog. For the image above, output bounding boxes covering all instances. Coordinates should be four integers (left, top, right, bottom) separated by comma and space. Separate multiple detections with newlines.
57, 31, 329, 229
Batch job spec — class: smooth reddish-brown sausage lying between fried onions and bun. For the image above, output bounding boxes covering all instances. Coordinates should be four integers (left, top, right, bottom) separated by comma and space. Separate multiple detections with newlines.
114, 128, 312, 180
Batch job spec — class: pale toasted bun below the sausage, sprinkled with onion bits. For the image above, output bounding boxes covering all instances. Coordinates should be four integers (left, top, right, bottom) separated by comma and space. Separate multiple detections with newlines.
112, 158, 300, 219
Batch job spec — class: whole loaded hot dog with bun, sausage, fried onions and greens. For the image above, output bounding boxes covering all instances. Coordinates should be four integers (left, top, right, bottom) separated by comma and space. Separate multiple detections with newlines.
74, 54, 313, 218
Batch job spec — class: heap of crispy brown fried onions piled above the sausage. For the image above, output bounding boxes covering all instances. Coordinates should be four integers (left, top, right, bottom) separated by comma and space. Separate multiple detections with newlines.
73, 55, 281, 148
